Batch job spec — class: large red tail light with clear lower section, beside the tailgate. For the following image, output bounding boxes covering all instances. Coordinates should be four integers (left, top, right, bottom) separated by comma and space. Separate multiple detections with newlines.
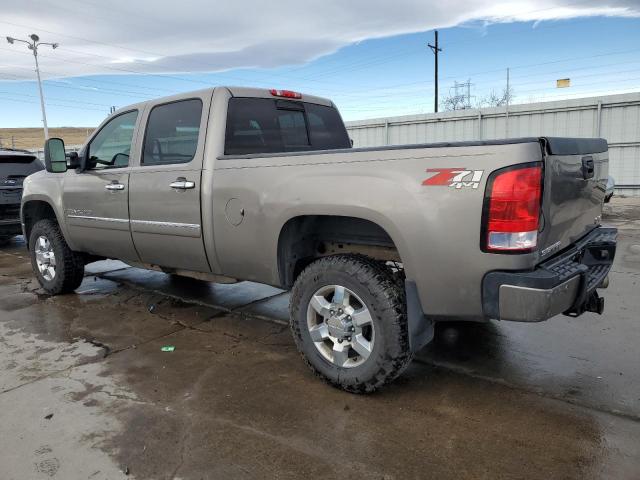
484, 165, 542, 252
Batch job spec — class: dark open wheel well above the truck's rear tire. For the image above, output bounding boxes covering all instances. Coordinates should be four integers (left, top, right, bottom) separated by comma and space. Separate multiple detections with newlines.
278, 215, 401, 288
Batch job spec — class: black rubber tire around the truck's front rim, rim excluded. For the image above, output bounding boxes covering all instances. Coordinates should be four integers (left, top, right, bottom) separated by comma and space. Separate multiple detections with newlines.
29, 219, 84, 295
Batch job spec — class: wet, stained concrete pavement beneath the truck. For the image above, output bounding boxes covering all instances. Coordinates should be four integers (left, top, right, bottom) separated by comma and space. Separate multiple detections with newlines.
0, 199, 640, 480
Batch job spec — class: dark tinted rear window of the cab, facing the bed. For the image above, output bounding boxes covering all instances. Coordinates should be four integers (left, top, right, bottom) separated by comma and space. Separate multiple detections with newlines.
224, 97, 351, 155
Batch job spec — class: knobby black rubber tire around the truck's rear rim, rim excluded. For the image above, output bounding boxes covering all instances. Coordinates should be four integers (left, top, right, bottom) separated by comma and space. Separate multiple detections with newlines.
289, 255, 412, 393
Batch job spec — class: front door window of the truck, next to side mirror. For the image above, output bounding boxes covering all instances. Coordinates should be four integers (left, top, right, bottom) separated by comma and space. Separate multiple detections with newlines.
88, 110, 138, 169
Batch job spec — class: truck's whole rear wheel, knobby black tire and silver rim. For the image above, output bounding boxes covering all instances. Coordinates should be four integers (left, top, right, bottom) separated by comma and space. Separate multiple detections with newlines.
290, 255, 411, 393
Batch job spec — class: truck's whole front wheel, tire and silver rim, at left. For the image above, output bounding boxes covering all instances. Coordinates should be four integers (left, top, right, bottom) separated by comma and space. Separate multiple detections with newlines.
29, 219, 84, 295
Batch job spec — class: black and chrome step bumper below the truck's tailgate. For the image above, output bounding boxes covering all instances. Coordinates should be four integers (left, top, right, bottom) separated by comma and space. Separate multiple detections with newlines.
482, 227, 618, 322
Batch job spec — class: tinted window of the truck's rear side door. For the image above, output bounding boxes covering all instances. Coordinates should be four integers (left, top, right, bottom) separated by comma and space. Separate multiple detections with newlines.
142, 99, 202, 165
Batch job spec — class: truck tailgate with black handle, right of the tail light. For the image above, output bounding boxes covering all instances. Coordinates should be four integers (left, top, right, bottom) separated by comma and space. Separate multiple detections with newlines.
538, 137, 609, 259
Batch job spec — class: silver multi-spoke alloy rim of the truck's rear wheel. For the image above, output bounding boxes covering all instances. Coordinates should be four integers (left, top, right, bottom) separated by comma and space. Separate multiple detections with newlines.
307, 285, 375, 368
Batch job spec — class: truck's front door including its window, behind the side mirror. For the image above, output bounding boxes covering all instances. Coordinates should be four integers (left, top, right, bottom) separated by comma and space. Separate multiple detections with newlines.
63, 110, 139, 260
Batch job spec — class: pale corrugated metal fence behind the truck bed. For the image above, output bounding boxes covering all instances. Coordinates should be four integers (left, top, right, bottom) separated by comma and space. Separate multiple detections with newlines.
347, 93, 640, 195
